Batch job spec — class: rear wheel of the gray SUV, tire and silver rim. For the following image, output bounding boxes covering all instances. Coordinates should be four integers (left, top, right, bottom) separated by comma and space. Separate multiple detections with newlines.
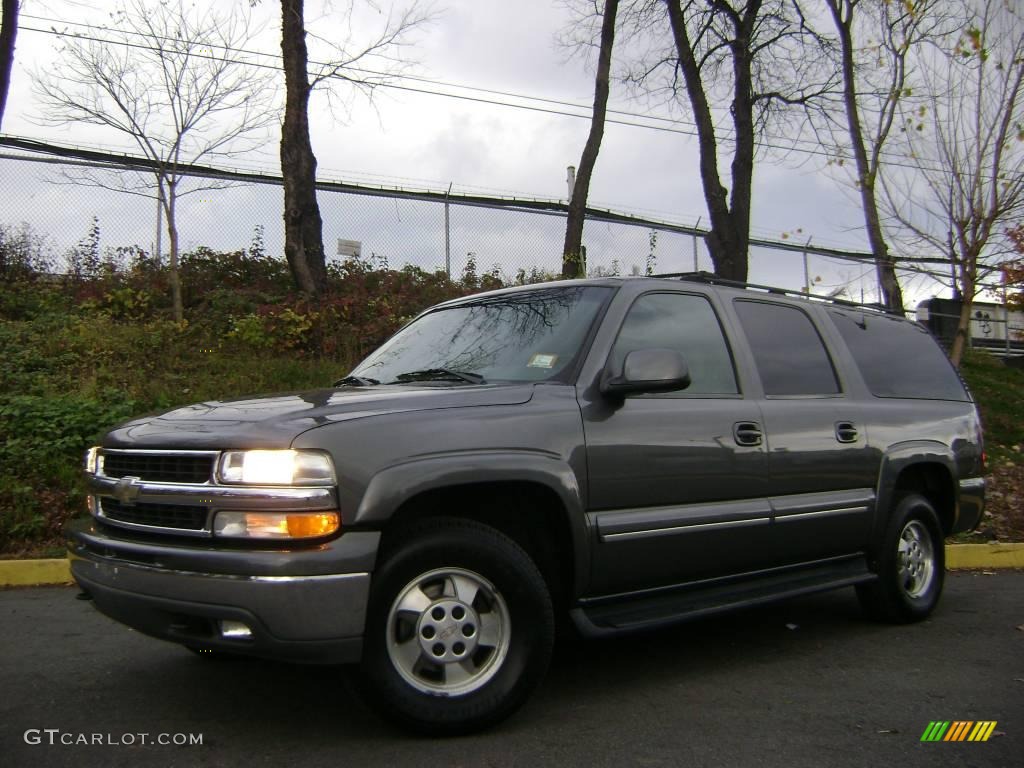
857, 494, 945, 624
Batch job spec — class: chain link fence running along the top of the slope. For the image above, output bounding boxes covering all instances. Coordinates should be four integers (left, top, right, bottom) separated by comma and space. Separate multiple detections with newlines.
0, 136, 937, 302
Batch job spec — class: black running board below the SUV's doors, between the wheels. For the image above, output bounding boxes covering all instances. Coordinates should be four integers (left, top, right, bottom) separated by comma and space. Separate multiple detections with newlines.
570, 556, 878, 637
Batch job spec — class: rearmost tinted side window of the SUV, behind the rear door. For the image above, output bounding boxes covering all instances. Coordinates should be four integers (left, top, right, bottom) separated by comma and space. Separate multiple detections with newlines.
828, 309, 970, 400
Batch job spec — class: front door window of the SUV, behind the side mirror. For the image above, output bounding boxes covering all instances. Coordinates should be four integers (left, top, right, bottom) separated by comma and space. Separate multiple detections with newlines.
611, 293, 739, 394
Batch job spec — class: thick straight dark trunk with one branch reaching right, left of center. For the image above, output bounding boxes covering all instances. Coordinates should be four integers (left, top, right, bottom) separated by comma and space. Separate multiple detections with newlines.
281, 0, 433, 295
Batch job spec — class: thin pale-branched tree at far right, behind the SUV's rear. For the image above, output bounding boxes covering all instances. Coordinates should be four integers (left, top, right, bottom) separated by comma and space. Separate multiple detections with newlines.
883, 0, 1024, 366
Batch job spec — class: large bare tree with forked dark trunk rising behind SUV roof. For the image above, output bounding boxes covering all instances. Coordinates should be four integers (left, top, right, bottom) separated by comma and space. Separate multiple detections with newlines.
606, 0, 838, 281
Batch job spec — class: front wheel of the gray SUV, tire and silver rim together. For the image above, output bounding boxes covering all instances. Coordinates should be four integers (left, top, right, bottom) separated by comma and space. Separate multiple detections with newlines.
359, 518, 554, 735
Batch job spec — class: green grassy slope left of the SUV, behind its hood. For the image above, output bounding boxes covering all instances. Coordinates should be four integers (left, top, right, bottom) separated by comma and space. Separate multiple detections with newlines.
0, 314, 351, 557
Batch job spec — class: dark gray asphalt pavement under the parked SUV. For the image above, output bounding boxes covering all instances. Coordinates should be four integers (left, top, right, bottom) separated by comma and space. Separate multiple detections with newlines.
0, 571, 1024, 768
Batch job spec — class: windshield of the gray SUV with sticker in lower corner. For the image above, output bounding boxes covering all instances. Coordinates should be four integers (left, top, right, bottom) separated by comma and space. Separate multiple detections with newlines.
351, 286, 611, 384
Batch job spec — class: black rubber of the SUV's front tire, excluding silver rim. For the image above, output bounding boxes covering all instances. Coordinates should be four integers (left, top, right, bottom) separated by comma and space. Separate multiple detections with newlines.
360, 520, 554, 735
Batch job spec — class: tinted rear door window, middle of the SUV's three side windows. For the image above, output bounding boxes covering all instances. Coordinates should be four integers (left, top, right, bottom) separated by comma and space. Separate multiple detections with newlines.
735, 300, 840, 395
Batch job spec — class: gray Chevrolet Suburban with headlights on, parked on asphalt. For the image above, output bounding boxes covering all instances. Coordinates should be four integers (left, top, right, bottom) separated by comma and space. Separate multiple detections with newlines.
68, 273, 985, 733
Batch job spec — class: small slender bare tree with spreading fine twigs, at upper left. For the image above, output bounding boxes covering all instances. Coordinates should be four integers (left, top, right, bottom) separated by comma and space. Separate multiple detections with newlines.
34, 0, 276, 322
